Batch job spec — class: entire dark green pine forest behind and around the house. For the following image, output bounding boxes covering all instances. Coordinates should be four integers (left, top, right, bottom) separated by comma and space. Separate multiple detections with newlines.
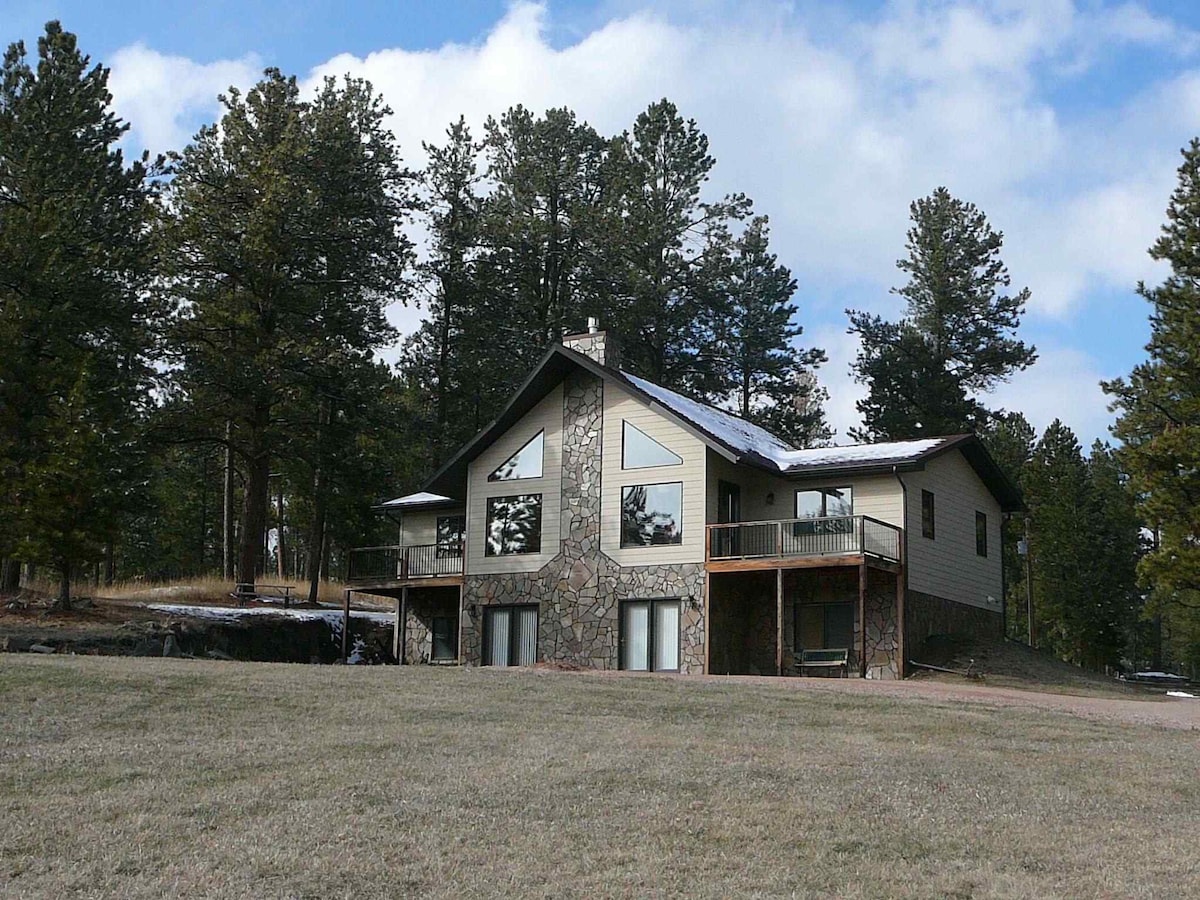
0, 23, 1200, 668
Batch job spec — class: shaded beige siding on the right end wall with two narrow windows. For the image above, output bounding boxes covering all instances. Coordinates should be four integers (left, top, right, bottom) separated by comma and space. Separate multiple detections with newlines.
904, 450, 1002, 611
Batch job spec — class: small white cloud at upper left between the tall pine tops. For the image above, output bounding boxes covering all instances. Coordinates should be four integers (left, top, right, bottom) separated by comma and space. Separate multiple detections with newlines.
108, 43, 262, 154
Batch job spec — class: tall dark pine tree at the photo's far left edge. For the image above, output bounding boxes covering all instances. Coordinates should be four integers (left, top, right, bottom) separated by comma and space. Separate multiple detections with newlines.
0, 22, 158, 605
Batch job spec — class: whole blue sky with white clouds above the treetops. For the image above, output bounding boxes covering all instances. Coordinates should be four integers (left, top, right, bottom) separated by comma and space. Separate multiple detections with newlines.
0, 0, 1200, 444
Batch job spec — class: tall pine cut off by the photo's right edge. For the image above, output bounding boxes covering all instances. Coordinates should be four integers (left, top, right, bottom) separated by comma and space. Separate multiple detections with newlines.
1104, 138, 1200, 662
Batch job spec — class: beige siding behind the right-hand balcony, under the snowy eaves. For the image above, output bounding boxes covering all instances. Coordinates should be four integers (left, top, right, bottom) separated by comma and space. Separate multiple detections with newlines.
708, 451, 904, 528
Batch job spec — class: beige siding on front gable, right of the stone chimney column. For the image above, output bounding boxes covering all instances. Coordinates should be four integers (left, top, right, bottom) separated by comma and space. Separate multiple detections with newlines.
600, 383, 707, 565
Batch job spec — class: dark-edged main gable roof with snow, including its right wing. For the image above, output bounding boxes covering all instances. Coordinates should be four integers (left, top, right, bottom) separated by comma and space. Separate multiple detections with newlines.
426, 346, 1024, 512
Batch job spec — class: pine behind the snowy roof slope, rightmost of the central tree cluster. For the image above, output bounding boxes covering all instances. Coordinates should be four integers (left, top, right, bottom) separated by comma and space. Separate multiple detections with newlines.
708, 216, 833, 446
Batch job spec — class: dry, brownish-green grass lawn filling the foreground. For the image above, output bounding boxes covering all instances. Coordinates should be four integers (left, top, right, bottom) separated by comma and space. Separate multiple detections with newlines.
0, 654, 1200, 898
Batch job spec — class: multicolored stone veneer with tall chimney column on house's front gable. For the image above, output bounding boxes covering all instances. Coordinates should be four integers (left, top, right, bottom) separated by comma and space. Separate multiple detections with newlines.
462, 371, 704, 673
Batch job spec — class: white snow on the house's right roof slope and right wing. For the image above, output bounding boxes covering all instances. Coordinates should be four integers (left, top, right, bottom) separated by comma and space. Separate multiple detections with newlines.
622, 372, 946, 473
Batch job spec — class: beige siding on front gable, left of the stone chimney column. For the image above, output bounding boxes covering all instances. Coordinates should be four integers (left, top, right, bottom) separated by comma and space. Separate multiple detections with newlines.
467, 386, 563, 575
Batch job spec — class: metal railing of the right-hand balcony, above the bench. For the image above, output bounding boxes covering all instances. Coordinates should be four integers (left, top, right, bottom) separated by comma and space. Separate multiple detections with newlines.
708, 516, 900, 563
